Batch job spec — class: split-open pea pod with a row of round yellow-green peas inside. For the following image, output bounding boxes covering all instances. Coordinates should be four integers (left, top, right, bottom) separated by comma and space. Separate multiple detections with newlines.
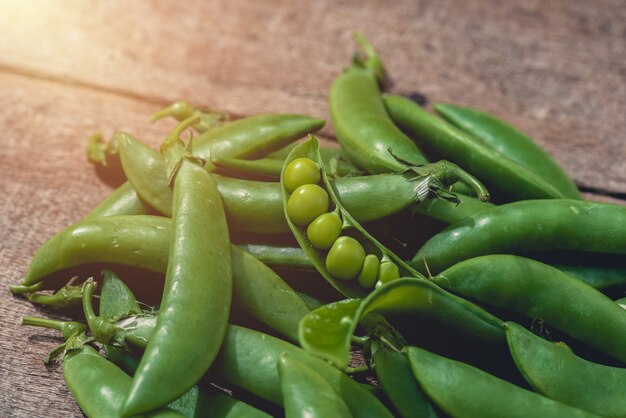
281, 136, 422, 298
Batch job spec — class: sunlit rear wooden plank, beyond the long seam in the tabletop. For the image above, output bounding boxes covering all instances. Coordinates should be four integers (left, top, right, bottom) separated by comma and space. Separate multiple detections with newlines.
0, 0, 626, 193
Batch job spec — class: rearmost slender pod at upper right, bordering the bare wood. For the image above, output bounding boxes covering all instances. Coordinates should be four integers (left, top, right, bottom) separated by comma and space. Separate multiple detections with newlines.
434, 103, 582, 199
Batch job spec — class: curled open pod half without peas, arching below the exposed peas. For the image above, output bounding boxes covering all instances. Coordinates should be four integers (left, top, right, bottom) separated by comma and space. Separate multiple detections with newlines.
299, 278, 504, 367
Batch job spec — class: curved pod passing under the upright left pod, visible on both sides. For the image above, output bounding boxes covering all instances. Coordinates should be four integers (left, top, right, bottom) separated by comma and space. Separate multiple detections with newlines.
11, 215, 309, 341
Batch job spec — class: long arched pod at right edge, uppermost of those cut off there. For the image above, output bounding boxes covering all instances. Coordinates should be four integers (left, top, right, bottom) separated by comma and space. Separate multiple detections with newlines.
411, 199, 626, 274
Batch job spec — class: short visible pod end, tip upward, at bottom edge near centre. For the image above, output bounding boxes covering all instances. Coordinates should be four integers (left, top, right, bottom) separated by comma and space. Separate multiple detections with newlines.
278, 355, 352, 418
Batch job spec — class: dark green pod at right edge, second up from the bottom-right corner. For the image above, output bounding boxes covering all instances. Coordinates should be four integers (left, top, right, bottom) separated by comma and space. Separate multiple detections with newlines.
432, 255, 626, 362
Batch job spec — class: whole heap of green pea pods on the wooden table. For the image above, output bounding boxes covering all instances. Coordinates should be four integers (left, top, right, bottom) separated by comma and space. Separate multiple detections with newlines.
11, 35, 626, 418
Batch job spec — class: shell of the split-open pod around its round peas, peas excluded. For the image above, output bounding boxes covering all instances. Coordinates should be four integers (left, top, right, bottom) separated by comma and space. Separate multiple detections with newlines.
281, 137, 423, 298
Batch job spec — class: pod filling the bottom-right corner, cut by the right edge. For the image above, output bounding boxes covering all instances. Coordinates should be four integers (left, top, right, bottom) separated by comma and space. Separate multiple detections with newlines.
505, 322, 626, 417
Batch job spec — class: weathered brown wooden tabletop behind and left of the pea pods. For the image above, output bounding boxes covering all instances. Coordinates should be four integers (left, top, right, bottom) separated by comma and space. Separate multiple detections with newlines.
0, 0, 626, 417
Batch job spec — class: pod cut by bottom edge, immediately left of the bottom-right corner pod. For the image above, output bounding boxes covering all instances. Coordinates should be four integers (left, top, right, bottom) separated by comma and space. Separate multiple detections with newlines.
406, 347, 598, 418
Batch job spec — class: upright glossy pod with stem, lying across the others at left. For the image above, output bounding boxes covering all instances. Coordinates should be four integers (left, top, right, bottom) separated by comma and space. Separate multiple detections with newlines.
121, 117, 232, 417
